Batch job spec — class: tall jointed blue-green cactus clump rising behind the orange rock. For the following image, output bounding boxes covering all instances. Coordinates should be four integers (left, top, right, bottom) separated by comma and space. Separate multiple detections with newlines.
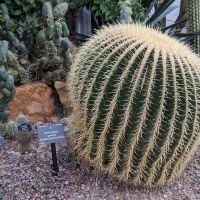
31, 0, 72, 83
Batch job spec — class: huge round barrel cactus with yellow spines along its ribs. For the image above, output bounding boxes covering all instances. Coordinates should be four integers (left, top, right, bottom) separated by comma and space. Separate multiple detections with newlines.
69, 24, 200, 186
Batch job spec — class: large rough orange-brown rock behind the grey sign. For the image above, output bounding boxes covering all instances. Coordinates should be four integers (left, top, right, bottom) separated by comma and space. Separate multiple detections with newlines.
9, 83, 57, 125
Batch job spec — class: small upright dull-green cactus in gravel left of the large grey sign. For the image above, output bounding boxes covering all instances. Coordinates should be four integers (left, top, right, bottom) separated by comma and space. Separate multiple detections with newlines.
16, 130, 31, 154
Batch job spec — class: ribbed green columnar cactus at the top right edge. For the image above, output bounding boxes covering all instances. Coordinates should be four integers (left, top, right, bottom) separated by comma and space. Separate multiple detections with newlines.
188, 0, 200, 54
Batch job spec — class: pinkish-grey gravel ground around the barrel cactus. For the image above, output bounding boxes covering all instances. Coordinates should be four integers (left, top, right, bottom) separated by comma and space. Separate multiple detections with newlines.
0, 134, 200, 200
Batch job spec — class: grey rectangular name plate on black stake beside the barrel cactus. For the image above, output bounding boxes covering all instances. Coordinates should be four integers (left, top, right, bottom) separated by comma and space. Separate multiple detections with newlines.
38, 124, 65, 144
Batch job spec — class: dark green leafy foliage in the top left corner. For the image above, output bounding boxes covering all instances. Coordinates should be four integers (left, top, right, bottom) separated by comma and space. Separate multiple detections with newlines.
3, 0, 45, 20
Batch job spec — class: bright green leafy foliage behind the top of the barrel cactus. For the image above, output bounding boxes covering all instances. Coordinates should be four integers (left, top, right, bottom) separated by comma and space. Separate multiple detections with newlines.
78, 0, 144, 22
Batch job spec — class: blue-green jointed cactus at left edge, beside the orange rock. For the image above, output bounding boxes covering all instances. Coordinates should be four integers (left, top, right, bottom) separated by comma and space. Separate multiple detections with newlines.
0, 50, 16, 122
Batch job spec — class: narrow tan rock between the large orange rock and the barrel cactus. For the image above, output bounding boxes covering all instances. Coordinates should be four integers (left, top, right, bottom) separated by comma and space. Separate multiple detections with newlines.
55, 81, 72, 116
